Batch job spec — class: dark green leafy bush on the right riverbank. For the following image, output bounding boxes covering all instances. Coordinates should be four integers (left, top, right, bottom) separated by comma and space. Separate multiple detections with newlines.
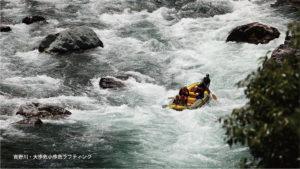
219, 23, 300, 168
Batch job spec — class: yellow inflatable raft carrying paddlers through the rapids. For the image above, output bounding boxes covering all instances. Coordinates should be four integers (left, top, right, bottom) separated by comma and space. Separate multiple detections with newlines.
168, 82, 210, 111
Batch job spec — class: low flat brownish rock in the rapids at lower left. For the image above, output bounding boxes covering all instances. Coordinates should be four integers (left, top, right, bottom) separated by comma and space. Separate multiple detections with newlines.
16, 103, 72, 118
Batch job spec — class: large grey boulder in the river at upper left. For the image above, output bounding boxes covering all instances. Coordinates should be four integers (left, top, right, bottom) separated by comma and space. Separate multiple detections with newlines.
39, 26, 103, 54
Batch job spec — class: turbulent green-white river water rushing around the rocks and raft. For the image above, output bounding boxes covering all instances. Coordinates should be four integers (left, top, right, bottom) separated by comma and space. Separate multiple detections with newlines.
0, 0, 291, 168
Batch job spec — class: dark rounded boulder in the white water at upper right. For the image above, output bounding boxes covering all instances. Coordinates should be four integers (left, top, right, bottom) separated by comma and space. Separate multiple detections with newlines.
226, 22, 280, 44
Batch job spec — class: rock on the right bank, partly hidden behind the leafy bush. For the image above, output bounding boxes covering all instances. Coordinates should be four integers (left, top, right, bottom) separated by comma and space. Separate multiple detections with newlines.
271, 36, 300, 63
